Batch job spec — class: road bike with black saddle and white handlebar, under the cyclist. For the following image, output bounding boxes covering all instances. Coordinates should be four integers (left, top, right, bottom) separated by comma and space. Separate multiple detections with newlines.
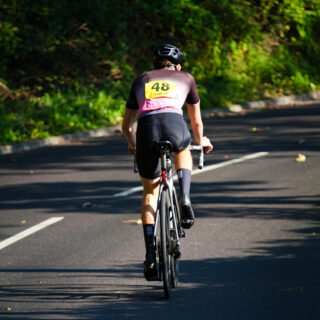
135, 141, 204, 299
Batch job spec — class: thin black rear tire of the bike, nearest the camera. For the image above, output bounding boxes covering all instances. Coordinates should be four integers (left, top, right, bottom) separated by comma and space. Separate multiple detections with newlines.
160, 190, 171, 299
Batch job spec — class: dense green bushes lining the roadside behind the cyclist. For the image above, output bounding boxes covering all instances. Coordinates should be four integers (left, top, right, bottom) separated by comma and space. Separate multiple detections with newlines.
0, 0, 320, 144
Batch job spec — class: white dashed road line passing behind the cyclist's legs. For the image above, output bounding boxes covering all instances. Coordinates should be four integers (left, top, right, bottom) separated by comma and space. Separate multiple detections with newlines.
113, 152, 269, 197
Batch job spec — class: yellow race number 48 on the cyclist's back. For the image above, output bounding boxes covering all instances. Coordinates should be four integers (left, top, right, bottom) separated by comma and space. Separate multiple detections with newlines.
145, 80, 177, 100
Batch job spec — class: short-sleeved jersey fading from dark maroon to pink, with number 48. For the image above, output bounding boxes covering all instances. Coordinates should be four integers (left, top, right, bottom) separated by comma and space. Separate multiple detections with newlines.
126, 69, 200, 116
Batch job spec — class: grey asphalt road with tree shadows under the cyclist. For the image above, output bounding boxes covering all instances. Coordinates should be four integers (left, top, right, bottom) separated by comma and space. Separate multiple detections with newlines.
0, 104, 320, 320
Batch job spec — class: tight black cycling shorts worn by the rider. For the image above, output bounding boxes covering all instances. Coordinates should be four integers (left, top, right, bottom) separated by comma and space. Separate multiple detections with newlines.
136, 112, 191, 179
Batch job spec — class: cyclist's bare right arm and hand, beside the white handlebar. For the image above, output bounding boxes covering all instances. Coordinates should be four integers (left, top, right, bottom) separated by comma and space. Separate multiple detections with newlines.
187, 102, 213, 153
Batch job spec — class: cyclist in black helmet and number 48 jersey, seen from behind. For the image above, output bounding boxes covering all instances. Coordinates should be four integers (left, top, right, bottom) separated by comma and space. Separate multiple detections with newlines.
122, 44, 212, 281
